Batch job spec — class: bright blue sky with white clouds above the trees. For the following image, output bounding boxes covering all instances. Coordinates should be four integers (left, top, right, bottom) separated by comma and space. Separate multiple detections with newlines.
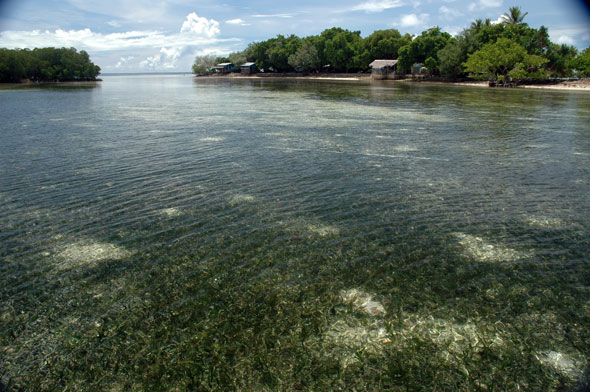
0, 0, 590, 73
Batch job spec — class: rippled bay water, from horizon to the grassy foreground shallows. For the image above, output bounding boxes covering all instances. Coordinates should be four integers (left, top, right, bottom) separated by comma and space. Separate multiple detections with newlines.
0, 75, 590, 390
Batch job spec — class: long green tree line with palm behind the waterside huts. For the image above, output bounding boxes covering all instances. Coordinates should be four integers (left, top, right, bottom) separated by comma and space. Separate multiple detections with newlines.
193, 7, 590, 83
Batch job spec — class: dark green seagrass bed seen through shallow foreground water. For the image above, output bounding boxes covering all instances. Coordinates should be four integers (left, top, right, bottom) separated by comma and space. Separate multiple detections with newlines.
0, 216, 590, 391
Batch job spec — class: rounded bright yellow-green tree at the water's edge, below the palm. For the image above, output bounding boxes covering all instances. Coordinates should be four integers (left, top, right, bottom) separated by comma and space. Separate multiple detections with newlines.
465, 38, 547, 86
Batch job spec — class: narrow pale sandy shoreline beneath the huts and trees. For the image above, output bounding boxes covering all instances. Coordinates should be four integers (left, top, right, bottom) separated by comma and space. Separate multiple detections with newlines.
196, 74, 590, 92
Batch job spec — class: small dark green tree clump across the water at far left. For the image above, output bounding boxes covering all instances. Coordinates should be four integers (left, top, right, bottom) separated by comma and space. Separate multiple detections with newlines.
0, 48, 100, 82
